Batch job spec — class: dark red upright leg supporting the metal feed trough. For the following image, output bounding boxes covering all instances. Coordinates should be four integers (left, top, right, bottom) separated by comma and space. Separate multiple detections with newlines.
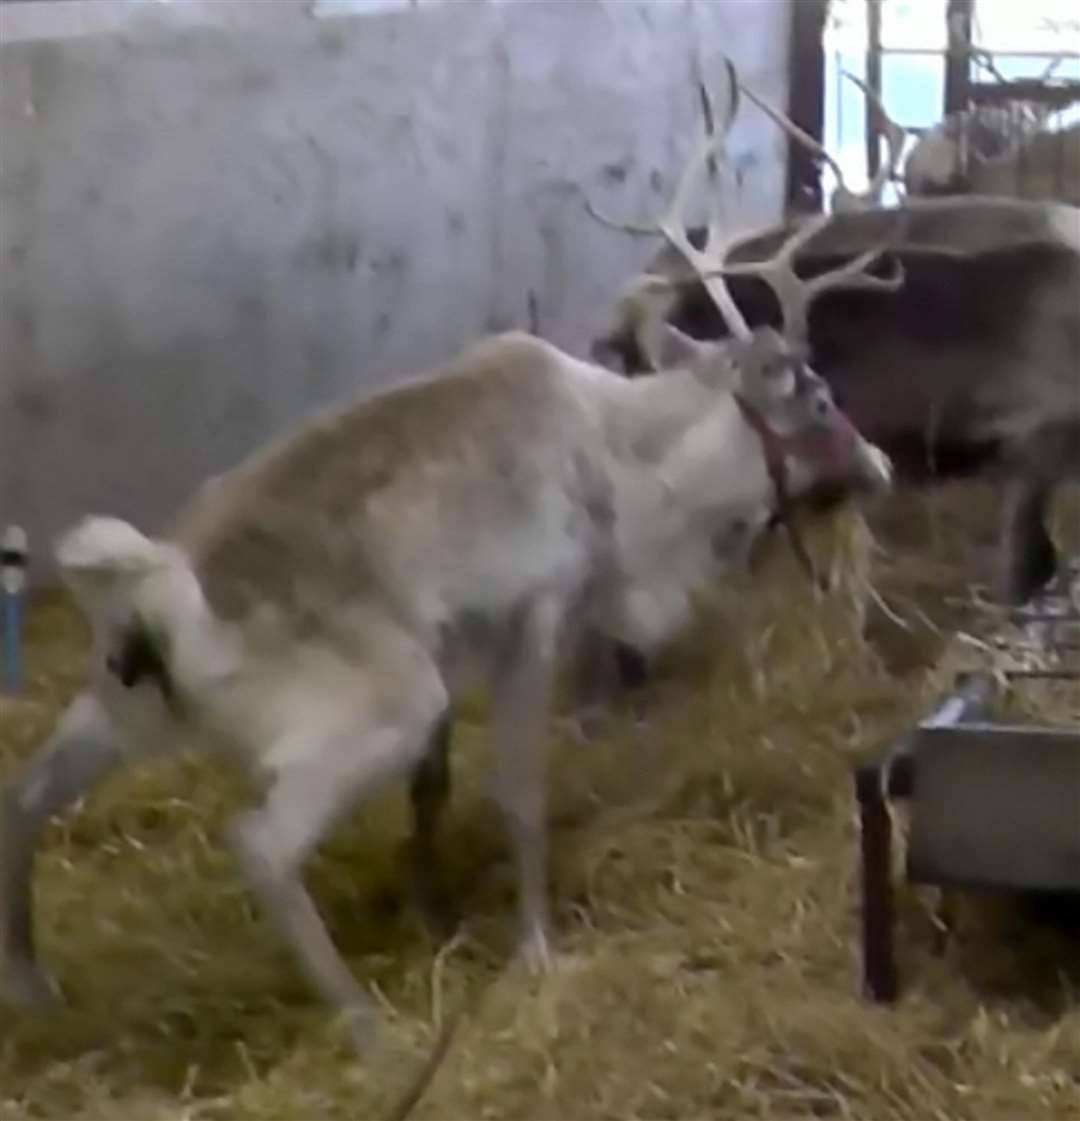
855, 765, 897, 1003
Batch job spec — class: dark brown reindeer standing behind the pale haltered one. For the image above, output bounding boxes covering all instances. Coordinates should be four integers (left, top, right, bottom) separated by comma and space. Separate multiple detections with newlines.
591, 74, 1080, 603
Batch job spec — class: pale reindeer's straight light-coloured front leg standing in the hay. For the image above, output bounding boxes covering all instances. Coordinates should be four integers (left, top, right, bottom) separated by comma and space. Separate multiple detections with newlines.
493, 597, 563, 970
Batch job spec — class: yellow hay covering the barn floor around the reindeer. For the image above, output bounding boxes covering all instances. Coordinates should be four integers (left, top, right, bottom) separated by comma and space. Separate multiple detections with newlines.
0, 489, 1080, 1121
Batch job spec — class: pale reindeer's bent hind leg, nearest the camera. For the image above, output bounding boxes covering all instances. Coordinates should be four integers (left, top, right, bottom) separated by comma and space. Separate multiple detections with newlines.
230, 672, 446, 1050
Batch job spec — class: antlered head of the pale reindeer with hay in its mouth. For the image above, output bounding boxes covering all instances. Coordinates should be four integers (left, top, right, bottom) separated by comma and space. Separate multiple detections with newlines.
593, 63, 904, 499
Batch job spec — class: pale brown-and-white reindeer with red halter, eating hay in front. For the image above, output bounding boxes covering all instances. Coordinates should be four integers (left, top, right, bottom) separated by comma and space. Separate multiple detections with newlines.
0, 61, 890, 1044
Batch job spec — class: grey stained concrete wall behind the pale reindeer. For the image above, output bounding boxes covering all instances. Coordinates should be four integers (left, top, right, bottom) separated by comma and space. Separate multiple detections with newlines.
0, 0, 788, 578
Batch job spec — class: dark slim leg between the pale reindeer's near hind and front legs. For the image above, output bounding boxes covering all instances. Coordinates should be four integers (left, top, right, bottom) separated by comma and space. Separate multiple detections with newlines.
409, 710, 456, 936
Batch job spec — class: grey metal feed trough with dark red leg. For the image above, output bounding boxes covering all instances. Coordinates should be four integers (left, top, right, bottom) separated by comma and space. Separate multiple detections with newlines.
855, 564, 1080, 1001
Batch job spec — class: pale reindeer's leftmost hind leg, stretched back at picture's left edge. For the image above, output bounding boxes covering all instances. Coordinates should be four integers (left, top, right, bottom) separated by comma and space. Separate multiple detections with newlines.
0, 693, 122, 1007
